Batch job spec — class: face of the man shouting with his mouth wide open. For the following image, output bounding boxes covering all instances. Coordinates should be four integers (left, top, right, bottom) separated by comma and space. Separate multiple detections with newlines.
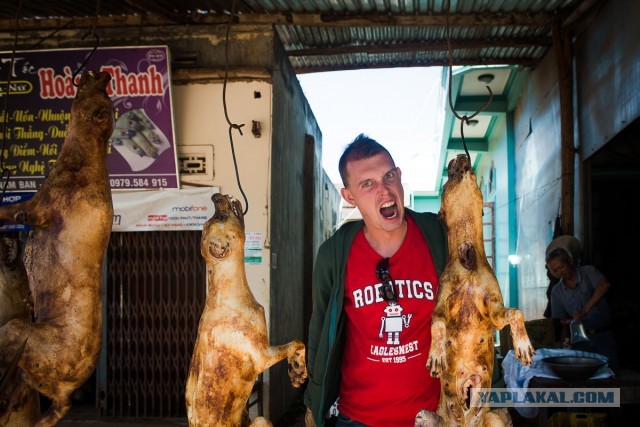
341, 153, 404, 231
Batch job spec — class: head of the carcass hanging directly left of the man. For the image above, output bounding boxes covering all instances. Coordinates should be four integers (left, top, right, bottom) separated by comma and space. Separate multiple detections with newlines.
201, 193, 245, 260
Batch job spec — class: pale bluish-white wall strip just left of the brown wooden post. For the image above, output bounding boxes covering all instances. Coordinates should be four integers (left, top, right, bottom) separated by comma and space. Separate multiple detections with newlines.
515, 44, 561, 319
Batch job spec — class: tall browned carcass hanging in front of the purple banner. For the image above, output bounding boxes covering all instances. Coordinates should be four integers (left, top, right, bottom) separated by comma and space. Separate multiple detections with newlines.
0, 72, 114, 427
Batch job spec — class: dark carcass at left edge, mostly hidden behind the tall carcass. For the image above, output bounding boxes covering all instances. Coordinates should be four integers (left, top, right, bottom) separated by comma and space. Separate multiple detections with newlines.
0, 237, 40, 427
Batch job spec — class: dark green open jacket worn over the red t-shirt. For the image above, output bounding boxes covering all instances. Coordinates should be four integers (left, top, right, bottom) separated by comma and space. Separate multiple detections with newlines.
304, 209, 448, 427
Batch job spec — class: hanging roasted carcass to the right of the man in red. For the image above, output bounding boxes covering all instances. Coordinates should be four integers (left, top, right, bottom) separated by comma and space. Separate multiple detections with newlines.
416, 155, 534, 427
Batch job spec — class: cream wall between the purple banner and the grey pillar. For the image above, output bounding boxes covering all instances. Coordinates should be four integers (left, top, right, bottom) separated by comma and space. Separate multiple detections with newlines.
172, 81, 272, 319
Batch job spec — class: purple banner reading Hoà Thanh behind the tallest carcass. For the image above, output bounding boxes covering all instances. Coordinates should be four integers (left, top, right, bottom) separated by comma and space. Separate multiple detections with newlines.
0, 46, 179, 192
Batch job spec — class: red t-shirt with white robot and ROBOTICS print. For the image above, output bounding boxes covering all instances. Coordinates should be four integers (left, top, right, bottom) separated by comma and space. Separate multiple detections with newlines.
338, 217, 440, 427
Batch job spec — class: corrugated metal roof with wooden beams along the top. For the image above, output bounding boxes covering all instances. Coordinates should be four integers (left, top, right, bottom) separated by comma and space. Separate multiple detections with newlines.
0, 0, 606, 73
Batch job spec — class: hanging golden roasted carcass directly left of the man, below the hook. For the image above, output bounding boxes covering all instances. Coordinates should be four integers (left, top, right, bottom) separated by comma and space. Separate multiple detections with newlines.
186, 193, 307, 427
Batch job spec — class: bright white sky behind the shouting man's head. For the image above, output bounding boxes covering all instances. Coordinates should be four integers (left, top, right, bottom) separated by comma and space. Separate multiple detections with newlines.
298, 67, 446, 195
